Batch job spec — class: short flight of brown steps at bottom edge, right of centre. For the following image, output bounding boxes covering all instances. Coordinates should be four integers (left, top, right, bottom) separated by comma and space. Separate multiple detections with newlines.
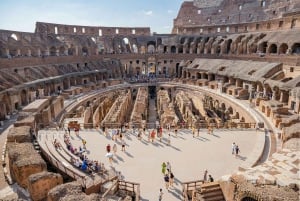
194, 182, 225, 201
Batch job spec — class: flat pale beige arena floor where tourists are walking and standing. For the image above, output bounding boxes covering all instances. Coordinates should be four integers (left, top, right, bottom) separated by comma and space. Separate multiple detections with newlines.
60, 130, 262, 201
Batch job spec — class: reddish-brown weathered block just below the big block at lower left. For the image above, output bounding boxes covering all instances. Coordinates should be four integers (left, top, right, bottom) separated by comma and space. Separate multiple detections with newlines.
28, 172, 63, 201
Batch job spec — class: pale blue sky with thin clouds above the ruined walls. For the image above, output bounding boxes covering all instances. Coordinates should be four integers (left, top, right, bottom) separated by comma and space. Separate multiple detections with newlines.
0, 0, 189, 33
